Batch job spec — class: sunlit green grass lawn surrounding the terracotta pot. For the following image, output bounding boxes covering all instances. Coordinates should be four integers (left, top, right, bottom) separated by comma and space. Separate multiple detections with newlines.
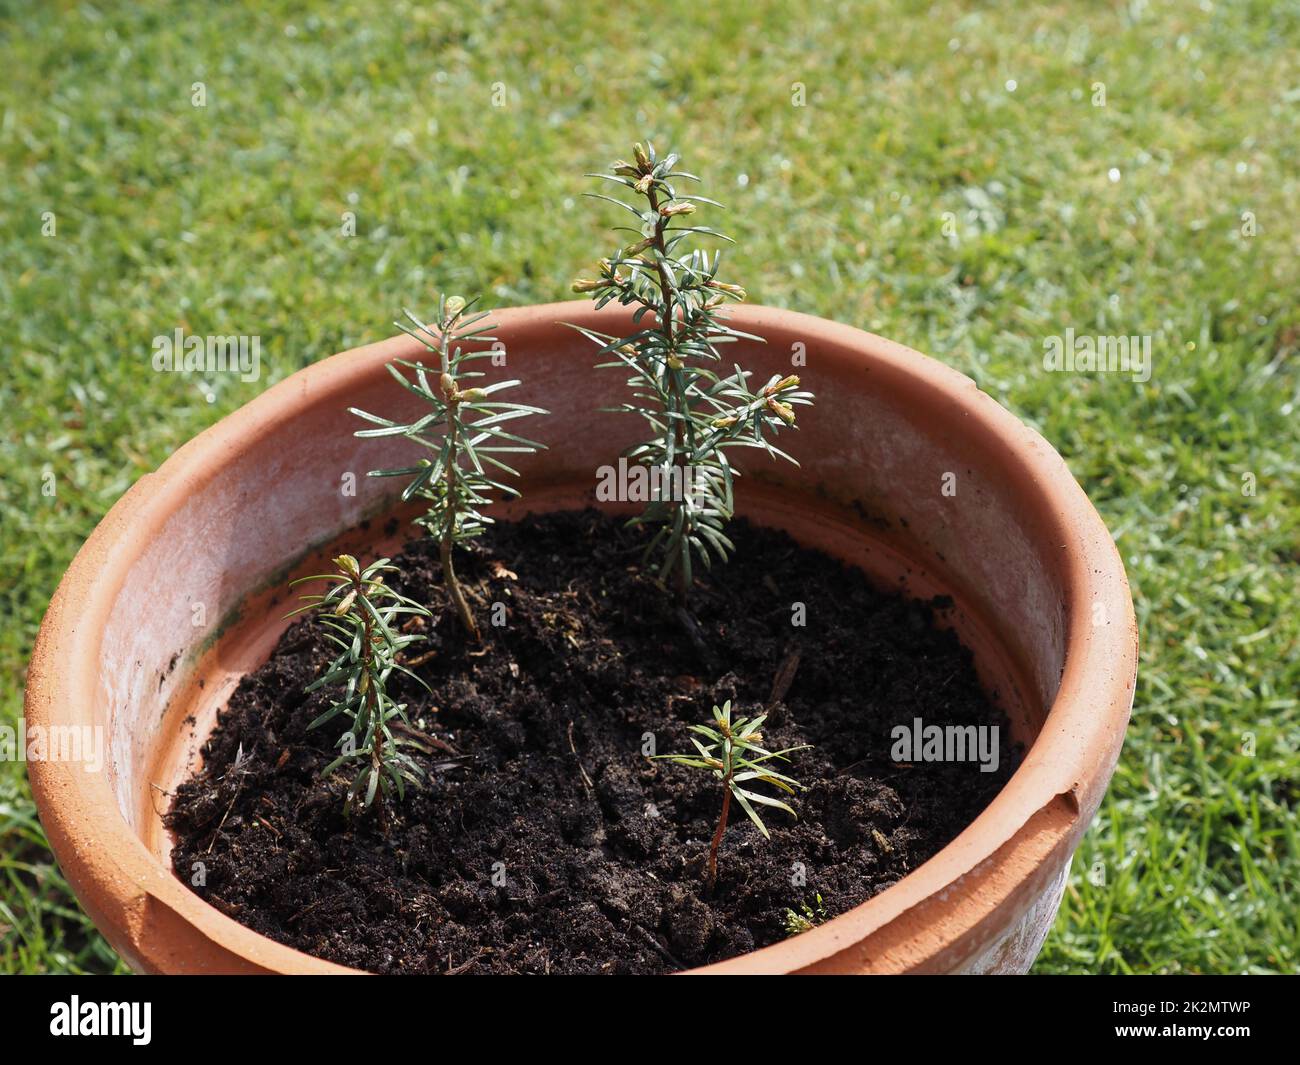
0, 0, 1300, 973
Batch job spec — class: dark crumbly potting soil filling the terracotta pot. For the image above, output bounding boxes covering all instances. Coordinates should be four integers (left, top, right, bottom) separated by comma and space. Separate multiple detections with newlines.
168, 510, 1019, 973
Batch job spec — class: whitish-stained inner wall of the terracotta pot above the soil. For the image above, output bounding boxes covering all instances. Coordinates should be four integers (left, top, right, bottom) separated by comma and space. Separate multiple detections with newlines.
65, 304, 1112, 972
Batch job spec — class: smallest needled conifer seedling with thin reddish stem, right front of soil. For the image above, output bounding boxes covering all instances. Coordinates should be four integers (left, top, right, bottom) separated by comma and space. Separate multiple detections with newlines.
654, 700, 809, 893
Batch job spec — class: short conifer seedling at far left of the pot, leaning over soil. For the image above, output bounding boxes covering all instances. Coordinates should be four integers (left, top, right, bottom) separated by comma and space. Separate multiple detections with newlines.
289, 555, 429, 811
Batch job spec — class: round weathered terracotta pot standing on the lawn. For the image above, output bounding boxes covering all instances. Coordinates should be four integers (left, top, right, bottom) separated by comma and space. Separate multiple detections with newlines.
26, 302, 1138, 973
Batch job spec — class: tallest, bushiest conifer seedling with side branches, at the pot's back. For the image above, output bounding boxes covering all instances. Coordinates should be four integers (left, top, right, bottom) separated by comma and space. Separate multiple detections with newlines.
573, 144, 813, 605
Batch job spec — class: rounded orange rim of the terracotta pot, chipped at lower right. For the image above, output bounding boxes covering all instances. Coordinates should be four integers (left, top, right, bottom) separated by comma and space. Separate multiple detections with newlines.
25, 300, 1138, 973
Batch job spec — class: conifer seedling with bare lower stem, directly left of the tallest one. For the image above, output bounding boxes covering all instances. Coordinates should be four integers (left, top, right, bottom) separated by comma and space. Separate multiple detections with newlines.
351, 296, 546, 640
